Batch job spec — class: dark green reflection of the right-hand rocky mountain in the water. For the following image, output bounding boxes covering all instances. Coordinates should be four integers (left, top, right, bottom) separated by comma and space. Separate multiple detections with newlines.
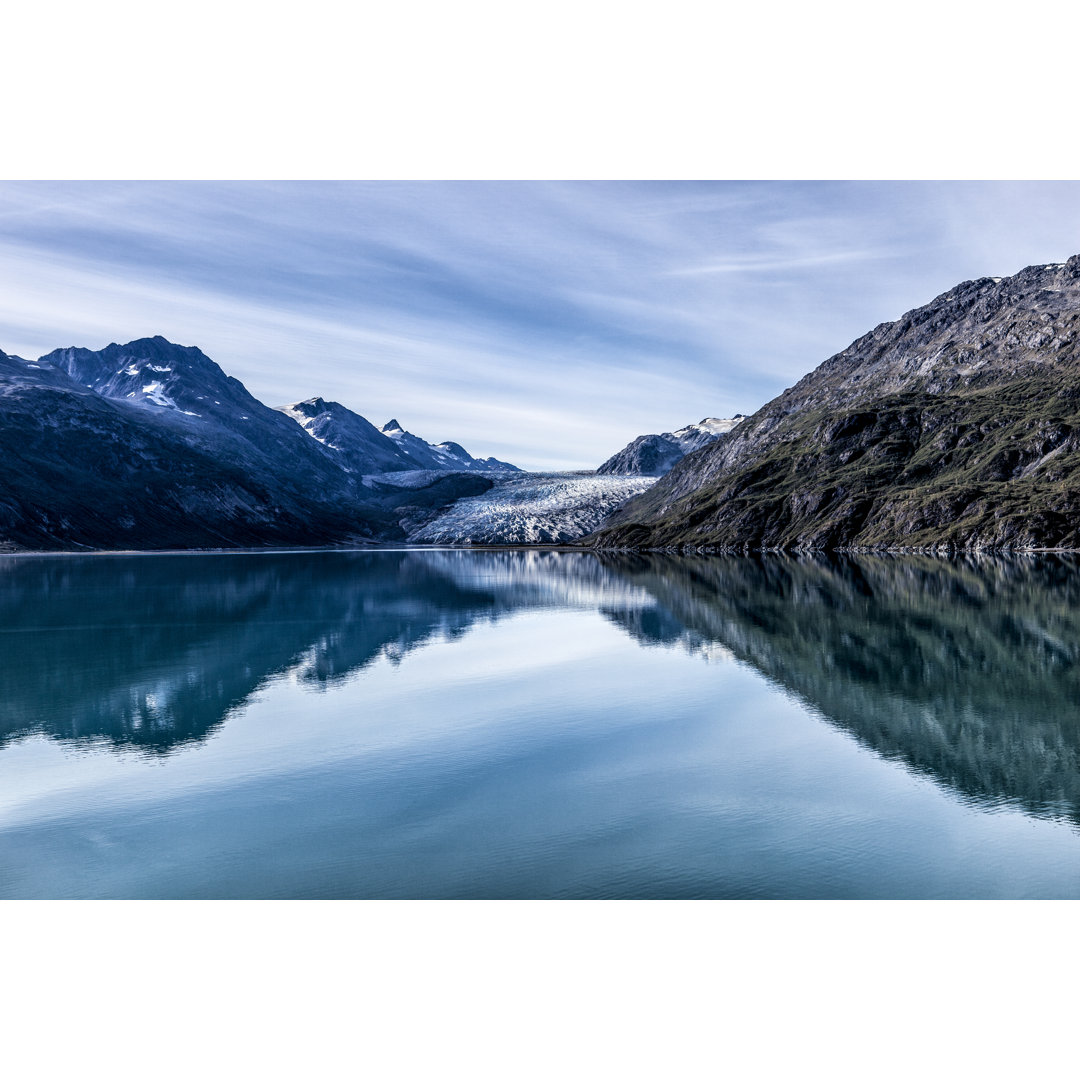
596, 555, 1080, 823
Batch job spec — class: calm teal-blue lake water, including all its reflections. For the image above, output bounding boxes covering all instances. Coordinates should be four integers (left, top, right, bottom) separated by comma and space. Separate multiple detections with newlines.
0, 551, 1080, 899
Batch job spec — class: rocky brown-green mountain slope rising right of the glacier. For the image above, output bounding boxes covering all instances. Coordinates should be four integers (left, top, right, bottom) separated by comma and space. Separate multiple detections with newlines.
590, 256, 1080, 551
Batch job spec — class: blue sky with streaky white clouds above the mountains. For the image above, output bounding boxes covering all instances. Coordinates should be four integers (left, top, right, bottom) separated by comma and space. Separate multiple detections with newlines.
0, 181, 1080, 470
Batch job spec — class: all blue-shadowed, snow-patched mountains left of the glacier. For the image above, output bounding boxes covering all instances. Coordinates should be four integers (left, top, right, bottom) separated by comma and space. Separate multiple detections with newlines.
0, 337, 514, 550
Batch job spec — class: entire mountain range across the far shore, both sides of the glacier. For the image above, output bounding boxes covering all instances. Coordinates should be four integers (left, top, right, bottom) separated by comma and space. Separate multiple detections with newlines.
14, 255, 1080, 552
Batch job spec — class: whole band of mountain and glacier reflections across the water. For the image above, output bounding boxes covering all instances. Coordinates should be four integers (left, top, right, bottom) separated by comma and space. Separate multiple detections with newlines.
0, 551, 1080, 824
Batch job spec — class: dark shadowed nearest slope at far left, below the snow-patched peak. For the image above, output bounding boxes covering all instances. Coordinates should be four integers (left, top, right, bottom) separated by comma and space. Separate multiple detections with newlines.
0, 343, 394, 549
